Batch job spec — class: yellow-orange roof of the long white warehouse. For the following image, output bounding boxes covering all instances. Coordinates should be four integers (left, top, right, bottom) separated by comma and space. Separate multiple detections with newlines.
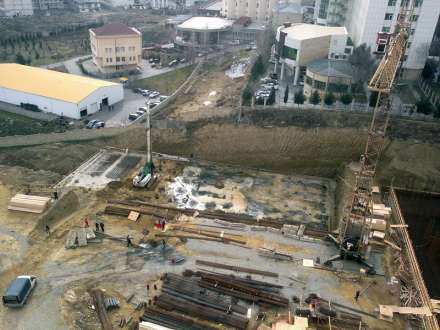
0, 63, 118, 103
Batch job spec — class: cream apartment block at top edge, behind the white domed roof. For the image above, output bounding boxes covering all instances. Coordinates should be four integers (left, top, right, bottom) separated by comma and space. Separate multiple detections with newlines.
222, 0, 277, 23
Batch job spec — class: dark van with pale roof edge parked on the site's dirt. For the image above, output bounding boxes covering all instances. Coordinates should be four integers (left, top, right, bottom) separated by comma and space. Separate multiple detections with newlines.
3, 275, 37, 307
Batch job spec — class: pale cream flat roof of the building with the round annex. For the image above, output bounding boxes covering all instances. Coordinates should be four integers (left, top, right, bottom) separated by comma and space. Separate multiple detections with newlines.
278, 23, 348, 40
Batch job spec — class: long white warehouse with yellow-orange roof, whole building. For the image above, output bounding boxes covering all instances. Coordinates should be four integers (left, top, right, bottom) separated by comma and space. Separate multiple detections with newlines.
0, 63, 124, 119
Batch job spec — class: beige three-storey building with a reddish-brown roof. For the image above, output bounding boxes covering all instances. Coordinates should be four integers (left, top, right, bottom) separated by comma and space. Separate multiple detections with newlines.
89, 23, 142, 73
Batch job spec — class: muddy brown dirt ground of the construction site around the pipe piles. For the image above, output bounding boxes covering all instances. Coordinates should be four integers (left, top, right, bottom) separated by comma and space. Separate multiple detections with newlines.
0, 155, 402, 330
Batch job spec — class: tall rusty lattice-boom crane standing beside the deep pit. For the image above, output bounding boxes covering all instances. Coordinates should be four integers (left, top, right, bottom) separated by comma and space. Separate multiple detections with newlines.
325, 2, 414, 274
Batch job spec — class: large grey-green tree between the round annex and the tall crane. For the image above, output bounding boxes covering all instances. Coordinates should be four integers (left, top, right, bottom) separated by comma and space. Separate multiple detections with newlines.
348, 44, 376, 84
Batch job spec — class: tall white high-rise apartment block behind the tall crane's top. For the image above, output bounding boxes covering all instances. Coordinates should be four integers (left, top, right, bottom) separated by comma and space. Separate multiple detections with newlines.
315, 0, 440, 79
